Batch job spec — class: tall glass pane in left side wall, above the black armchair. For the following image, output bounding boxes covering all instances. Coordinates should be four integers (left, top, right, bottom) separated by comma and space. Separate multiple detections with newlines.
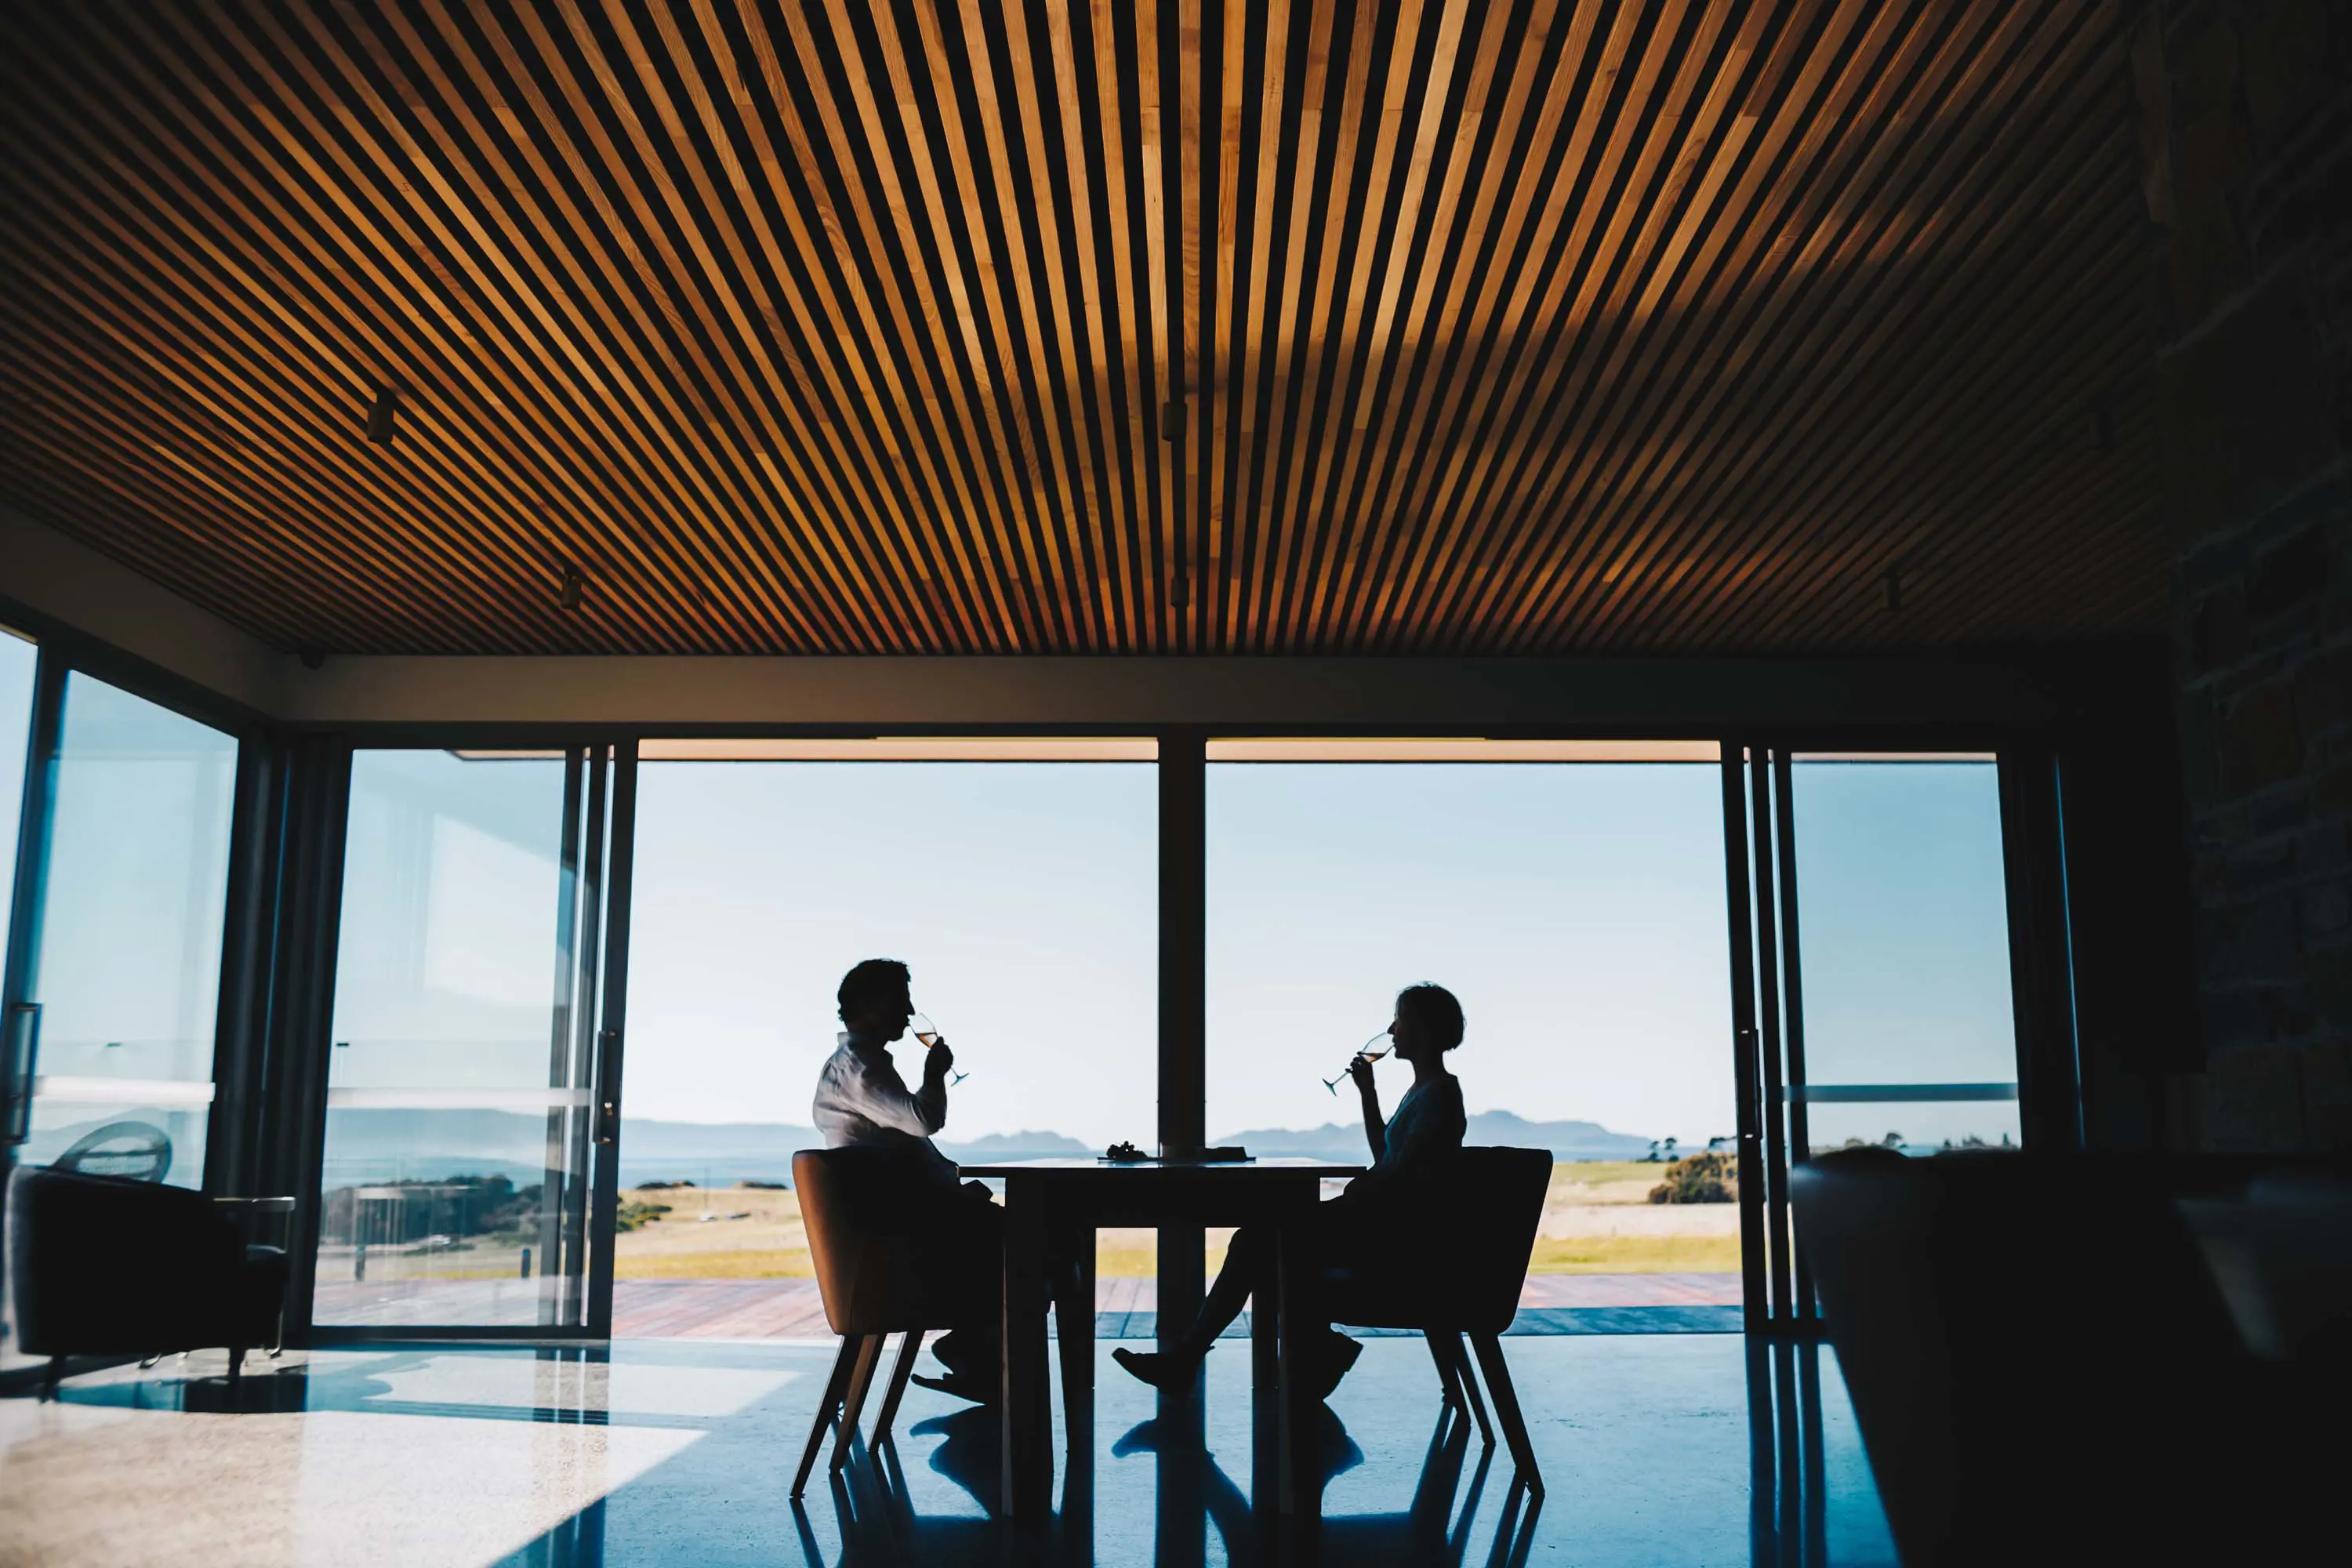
16, 673, 238, 1187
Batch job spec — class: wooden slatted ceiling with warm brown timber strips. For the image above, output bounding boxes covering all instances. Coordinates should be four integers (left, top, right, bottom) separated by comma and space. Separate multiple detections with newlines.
0, 0, 2164, 654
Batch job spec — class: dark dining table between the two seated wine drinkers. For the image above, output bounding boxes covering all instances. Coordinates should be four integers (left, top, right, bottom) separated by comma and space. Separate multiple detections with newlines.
962, 1159, 1364, 1523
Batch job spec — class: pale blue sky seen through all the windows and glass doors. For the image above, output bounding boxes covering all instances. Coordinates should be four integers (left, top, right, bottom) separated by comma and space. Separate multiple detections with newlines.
0, 640, 2016, 1166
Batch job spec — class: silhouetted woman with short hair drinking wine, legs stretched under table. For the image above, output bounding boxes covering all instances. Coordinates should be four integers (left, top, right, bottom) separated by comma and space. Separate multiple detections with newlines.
1110, 985, 1468, 1396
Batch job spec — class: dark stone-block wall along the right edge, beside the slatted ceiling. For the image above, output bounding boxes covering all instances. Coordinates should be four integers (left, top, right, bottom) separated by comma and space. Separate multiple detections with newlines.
2131, 0, 2352, 1149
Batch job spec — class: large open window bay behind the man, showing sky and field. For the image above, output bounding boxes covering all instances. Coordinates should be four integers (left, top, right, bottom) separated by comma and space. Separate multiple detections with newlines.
614, 741, 1160, 1335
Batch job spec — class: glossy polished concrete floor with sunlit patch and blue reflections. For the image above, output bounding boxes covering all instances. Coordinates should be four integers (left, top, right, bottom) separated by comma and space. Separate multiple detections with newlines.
0, 1335, 1893, 1568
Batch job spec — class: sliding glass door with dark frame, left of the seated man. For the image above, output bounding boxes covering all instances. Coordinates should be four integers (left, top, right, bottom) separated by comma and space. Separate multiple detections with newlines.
310, 748, 614, 1335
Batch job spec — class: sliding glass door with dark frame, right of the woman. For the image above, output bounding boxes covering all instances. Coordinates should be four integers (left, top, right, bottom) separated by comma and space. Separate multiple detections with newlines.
1724, 748, 2025, 1326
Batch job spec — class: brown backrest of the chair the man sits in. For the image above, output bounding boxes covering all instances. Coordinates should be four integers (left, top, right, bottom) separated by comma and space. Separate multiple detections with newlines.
793, 1149, 943, 1335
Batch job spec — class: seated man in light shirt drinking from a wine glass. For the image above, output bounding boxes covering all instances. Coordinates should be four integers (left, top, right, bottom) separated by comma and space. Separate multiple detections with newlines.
811, 959, 1004, 1403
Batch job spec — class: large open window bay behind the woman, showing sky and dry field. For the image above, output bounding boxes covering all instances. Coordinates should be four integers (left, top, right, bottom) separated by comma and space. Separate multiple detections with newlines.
1207, 741, 1740, 1326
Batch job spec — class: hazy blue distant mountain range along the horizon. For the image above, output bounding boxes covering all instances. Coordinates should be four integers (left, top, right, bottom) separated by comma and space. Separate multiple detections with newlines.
280, 1109, 1649, 1187
